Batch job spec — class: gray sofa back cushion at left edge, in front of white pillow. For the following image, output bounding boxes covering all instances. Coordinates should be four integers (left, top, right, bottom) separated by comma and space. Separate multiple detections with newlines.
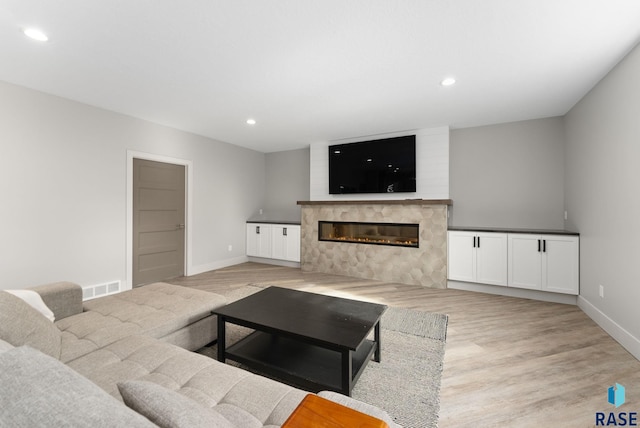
0, 291, 62, 359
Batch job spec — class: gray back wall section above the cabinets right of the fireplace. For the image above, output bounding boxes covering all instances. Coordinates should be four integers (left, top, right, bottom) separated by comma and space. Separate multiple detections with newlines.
449, 118, 564, 229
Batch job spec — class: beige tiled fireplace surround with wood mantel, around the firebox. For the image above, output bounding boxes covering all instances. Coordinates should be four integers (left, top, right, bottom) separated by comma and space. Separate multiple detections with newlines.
298, 199, 452, 288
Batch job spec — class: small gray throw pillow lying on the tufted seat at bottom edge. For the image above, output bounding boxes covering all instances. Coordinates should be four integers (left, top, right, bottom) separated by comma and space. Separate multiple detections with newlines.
118, 380, 233, 428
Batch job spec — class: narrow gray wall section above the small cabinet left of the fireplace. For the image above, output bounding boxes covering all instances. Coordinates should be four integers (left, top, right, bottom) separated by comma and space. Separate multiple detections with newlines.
264, 148, 309, 220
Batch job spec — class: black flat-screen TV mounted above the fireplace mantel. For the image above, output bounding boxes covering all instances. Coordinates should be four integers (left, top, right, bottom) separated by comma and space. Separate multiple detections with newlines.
329, 135, 416, 195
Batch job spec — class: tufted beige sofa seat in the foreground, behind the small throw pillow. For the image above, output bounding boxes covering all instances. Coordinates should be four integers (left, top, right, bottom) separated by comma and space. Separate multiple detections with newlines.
68, 336, 307, 428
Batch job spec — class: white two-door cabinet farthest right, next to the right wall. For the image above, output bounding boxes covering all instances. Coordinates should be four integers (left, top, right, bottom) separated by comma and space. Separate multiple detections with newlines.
508, 234, 579, 295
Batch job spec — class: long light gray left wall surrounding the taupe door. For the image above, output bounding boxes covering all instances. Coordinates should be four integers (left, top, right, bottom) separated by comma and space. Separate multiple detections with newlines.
0, 78, 265, 289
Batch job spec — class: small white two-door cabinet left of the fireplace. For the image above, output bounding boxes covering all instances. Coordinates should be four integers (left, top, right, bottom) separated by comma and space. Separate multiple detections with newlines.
247, 223, 300, 262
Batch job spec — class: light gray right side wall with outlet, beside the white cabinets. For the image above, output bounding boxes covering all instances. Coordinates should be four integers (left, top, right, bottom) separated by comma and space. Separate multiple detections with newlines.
565, 41, 640, 352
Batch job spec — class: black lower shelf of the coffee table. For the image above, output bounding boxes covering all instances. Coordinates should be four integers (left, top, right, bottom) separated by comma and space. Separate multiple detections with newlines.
225, 331, 377, 395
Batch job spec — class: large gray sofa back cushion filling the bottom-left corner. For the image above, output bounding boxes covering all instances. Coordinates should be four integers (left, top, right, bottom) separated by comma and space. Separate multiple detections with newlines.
0, 347, 154, 428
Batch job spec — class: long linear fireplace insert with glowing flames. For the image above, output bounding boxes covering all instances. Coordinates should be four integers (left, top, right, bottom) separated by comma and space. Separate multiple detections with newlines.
318, 221, 420, 248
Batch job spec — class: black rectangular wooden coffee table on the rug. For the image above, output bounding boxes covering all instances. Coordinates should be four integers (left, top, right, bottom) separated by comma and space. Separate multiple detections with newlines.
213, 287, 387, 395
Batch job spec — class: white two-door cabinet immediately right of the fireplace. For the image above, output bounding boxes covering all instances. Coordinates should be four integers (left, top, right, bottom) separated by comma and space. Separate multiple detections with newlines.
447, 231, 507, 286
